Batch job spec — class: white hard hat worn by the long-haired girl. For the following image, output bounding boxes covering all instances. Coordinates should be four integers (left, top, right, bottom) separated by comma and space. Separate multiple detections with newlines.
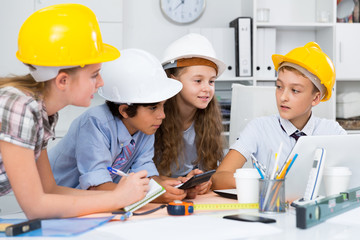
161, 33, 226, 76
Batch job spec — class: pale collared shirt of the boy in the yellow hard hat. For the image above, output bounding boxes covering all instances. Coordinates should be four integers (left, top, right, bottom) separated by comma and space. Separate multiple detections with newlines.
230, 114, 346, 169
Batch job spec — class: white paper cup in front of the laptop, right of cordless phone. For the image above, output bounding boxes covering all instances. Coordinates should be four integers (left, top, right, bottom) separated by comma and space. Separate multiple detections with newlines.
323, 167, 352, 196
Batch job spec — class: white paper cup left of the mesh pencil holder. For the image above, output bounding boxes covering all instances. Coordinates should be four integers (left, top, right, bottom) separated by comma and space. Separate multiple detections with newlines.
234, 168, 260, 203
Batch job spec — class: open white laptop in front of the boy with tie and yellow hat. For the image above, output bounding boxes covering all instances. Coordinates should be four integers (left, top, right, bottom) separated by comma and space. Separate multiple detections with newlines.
285, 134, 360, 201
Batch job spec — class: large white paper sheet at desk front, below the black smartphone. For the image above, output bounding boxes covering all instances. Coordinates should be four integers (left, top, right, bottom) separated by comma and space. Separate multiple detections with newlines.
96, 215, 282, 240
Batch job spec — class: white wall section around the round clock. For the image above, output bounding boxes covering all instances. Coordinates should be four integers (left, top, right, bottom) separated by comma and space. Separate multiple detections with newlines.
123, 0, 242, 60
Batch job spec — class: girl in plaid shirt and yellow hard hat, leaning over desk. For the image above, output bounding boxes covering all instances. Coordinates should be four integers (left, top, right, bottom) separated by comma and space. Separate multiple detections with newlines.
0, 4, 149, 219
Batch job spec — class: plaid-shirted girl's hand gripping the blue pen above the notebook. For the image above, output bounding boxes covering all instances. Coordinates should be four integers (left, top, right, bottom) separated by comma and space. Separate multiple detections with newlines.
115, 170, 150, 207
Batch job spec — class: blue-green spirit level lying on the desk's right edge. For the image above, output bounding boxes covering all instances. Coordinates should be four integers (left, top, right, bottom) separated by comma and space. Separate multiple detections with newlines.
296, 187, 360, 229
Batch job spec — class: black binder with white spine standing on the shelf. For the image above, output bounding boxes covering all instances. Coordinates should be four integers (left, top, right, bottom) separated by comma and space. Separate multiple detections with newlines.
229, 17, 253, 77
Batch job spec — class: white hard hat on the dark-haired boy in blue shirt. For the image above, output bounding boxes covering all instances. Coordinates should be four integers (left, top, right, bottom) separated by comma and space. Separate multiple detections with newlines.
98, 49, 182, 104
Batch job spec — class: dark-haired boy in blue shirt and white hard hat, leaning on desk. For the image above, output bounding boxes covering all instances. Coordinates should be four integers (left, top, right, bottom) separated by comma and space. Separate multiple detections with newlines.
49, 49, 186, 201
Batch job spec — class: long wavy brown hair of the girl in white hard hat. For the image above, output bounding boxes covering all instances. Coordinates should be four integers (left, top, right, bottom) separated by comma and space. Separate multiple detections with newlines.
154, 68, 223, 176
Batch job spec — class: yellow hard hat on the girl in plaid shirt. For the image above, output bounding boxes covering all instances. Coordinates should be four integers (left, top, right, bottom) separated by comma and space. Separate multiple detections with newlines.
16, 4, 120, 66
